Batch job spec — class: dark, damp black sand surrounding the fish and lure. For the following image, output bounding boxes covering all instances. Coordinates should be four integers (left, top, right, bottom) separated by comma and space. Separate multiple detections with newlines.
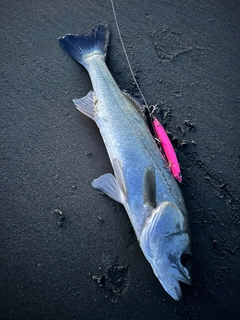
0, 0, 240, 320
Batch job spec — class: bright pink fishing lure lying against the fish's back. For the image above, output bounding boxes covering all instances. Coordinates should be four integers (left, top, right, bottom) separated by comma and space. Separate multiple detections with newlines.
152, 117, 182, 182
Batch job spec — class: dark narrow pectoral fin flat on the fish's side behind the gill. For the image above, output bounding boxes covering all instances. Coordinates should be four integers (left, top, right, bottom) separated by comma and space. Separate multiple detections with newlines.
143, 166, 156, 208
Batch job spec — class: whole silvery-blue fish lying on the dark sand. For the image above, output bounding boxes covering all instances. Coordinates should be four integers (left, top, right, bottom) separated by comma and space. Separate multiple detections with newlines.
59, 24, 191, 301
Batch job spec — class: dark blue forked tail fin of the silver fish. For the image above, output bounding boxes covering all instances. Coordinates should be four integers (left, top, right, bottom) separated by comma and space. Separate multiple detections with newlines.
58, 25, 110, 67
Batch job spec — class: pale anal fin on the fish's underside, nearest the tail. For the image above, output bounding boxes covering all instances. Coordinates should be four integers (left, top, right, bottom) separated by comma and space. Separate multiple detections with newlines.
73, 90, 97, 121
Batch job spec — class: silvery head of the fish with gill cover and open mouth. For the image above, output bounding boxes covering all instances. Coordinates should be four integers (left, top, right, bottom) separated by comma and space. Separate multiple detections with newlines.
140, 201, 191, 301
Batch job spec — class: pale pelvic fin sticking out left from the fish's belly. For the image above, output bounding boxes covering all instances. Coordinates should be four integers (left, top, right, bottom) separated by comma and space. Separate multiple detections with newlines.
92, 173, 126, 204
